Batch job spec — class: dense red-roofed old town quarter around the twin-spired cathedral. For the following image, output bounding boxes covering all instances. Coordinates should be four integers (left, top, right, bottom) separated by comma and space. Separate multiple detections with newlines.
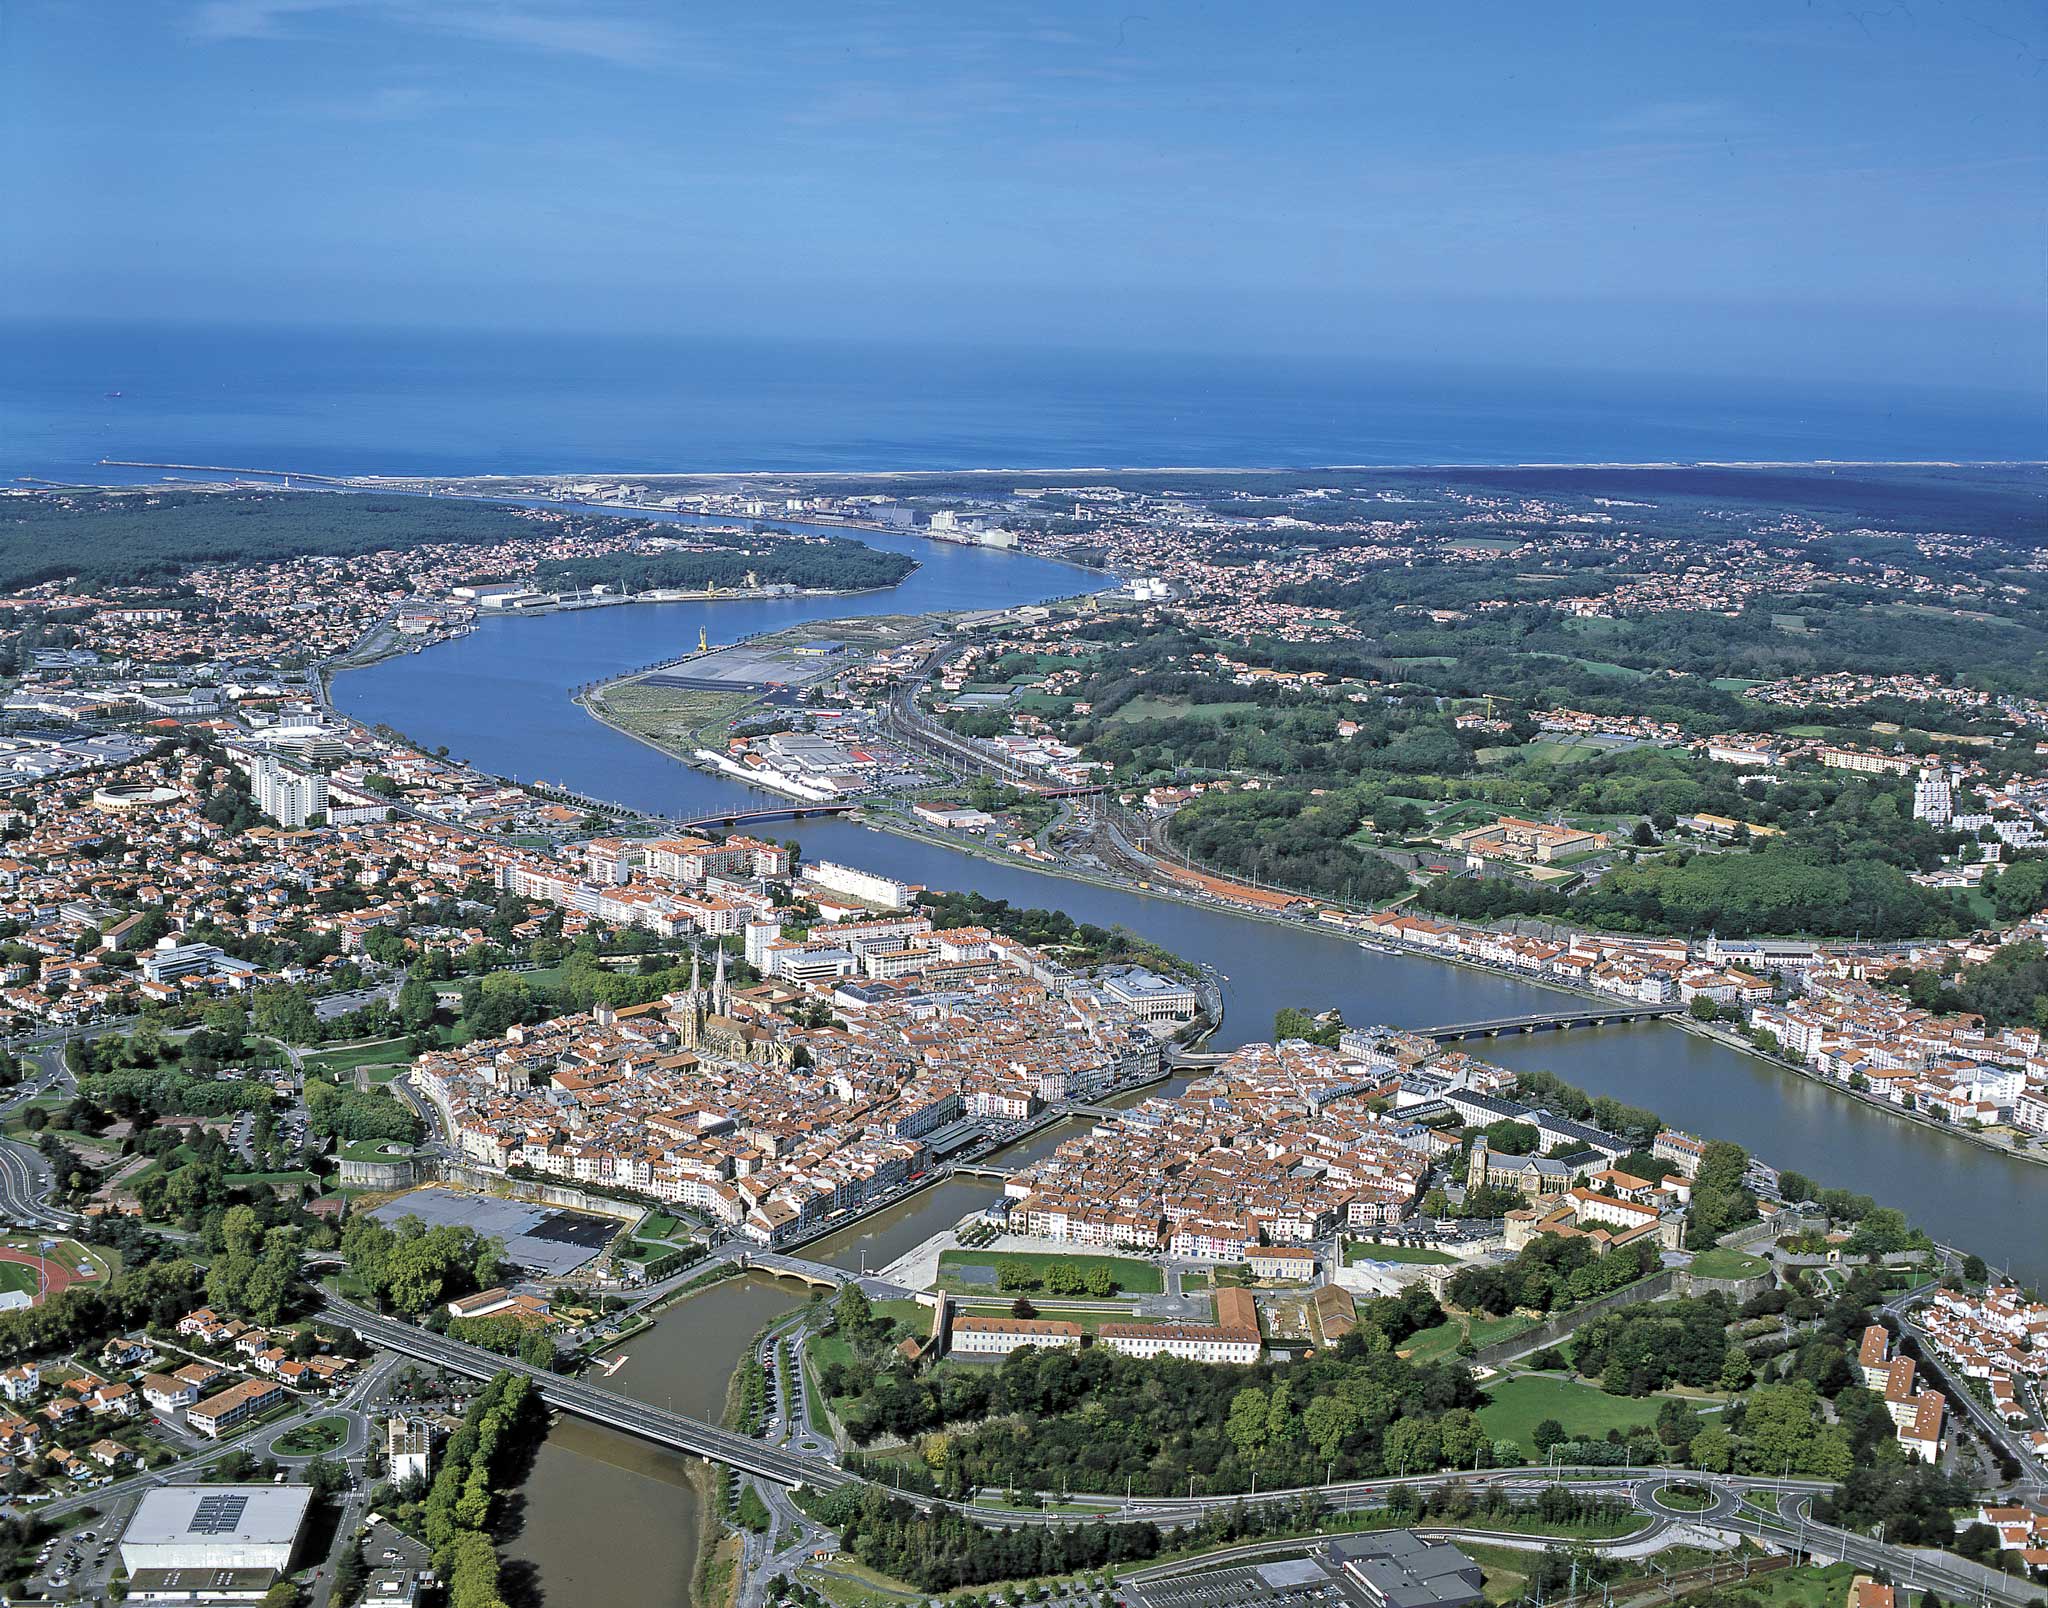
412, 916, 1161, 1245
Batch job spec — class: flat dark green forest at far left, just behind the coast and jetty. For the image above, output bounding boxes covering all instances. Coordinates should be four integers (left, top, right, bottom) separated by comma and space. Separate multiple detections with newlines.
0, 488, 631, 590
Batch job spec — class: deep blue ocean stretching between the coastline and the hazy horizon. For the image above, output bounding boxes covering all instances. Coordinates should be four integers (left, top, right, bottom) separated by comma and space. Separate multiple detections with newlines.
0, 324, 2048, 481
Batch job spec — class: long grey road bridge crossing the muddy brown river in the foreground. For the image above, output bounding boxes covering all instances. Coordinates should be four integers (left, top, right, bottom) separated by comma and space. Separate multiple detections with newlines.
322, 1301, 860, 1489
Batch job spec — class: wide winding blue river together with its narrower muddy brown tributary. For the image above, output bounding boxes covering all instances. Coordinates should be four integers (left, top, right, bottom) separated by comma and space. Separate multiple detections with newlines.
334, 520, 2048, 1606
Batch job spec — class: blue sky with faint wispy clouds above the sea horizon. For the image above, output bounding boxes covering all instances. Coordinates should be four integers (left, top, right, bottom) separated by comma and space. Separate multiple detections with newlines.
12, 0, 2048, 391
